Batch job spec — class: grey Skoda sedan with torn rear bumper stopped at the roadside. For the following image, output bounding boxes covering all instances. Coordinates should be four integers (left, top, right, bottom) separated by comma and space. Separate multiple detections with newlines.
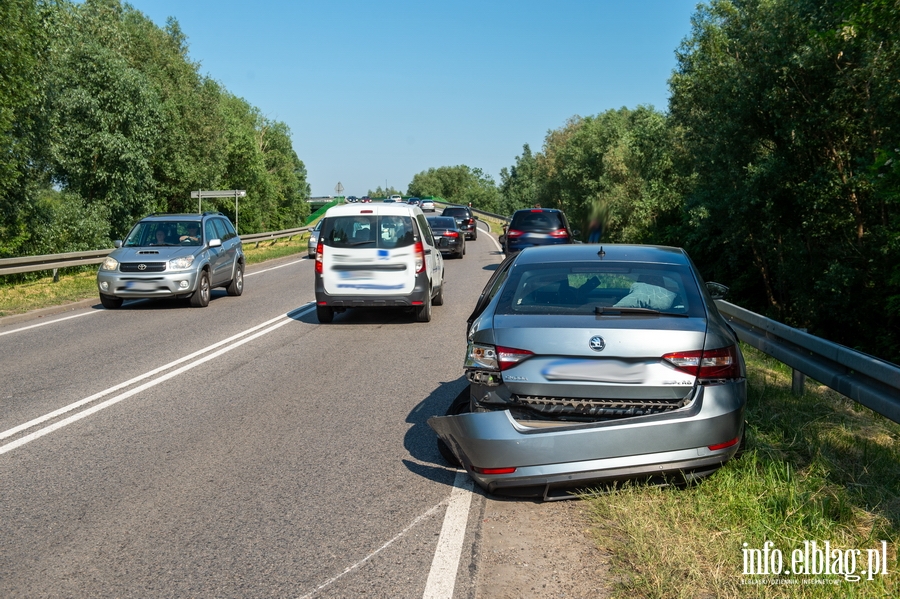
428, 245, 747, 498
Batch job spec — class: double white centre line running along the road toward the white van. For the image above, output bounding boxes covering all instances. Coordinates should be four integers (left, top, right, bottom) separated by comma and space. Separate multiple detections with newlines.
0, 305, 311, 454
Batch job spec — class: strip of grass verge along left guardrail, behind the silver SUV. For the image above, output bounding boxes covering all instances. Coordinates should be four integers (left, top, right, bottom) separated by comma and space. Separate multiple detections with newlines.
0, 233, 309, 317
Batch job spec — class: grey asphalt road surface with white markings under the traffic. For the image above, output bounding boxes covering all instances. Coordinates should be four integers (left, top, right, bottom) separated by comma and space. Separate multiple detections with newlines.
0, 225, 501, 598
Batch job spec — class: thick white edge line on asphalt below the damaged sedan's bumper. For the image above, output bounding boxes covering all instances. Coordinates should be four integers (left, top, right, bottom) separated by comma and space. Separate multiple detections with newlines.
422, 470, 473, 599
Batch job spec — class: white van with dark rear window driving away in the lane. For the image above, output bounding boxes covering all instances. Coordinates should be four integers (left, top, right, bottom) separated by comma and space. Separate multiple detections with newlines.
316, 203, 444, 323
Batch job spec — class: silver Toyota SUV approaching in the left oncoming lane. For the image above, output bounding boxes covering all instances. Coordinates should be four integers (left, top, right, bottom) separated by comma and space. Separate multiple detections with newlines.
97, 212, 245, 308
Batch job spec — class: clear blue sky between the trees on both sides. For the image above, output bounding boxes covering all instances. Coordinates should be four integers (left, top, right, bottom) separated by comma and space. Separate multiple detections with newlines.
130, 0, 697, 196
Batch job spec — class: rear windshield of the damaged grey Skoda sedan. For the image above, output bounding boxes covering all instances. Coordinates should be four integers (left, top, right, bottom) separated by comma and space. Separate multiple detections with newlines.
496, 262, 706, 317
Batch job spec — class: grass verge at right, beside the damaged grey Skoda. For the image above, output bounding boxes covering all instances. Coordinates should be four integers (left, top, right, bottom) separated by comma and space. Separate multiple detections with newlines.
587, 346, 900, 599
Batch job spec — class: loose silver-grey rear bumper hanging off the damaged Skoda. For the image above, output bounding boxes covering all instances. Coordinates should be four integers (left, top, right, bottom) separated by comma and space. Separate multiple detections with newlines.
428, 384, 743, 499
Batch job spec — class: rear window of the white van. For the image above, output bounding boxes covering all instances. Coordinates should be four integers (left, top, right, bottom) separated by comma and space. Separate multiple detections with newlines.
320, 214, 415, 249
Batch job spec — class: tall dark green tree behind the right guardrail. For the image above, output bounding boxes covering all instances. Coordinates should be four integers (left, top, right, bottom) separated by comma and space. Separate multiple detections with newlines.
670, 0, 900, 359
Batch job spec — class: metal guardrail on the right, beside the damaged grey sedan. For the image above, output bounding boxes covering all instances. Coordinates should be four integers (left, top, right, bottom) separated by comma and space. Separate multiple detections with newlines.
716, 300, 900, 422
